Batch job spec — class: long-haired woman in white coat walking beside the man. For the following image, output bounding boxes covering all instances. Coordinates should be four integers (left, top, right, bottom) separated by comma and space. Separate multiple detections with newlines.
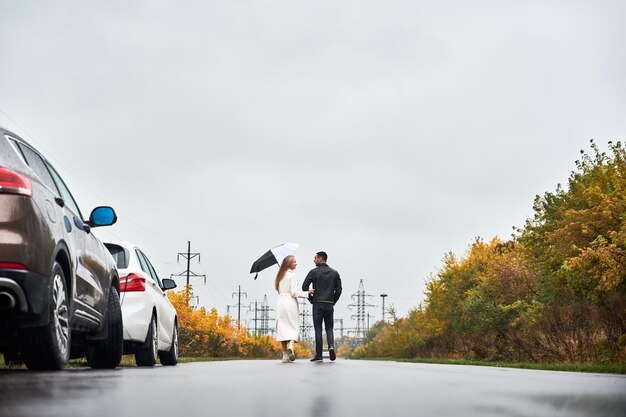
274, 255, 315, 363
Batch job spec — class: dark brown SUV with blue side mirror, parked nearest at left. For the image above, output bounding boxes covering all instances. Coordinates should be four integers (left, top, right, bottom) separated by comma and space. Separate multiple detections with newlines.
0, 127, 123, 370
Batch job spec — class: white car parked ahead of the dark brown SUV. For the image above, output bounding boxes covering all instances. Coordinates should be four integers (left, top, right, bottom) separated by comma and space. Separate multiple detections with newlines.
104, 241, 178, 366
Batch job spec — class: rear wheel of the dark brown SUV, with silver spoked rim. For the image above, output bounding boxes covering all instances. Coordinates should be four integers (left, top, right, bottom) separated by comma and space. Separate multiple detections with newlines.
22, 261, 71, 370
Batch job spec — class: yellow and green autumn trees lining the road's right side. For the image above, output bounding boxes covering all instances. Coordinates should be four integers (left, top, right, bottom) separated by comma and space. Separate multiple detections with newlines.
347, 141, 626, 372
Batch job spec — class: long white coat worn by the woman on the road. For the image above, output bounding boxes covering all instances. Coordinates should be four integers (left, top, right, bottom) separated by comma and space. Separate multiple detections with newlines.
276, 269, 309, 342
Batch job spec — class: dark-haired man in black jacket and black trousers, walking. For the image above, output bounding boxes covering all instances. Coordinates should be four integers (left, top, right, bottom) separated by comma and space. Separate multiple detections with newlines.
302, 252, 341, 362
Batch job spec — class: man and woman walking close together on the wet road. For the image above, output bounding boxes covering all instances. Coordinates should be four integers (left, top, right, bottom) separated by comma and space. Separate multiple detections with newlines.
274, 252, 341, 363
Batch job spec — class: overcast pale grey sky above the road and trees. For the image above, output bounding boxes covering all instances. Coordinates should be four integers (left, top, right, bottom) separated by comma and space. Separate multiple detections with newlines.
0, 0, 626, 332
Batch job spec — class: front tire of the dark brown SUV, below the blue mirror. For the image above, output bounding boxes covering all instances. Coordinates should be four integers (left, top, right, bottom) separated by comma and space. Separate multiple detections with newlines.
87, 287, 124, 369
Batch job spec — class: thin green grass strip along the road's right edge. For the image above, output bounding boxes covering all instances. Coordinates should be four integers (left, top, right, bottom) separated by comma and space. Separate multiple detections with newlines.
365, 358, 626, 375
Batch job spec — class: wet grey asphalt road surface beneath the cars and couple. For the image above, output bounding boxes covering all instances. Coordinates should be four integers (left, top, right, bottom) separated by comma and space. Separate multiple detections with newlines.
0, 359, 626, 417
